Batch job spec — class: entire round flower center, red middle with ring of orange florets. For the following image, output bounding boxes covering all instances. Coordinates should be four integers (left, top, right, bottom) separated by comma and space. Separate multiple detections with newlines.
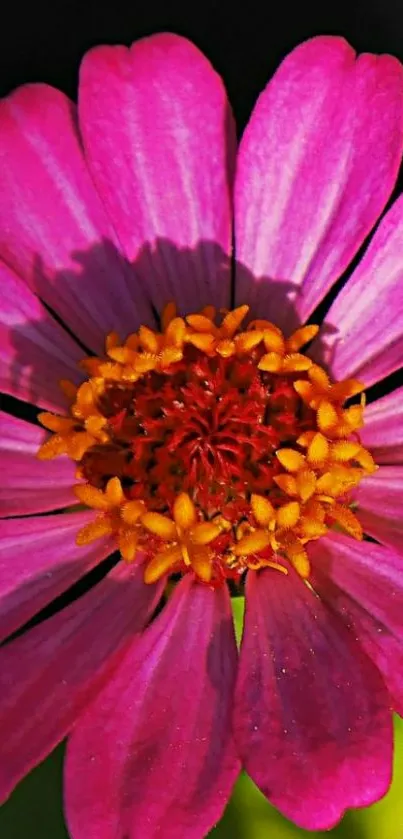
38, 304, 377, 585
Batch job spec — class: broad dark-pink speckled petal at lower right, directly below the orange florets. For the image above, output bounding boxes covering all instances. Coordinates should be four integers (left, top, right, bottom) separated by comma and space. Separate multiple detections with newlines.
235, 569, 392, 830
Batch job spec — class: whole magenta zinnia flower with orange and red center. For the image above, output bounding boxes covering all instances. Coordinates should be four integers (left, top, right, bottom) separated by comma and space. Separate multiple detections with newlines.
0, 29, 403, 839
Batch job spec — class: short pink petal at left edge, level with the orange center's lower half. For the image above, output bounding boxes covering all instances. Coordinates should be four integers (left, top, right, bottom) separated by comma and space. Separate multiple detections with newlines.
0, 411, 77, 516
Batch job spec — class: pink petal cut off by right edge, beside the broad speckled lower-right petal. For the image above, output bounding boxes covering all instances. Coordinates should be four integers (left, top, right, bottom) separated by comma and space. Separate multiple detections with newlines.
309, 533, 403, 715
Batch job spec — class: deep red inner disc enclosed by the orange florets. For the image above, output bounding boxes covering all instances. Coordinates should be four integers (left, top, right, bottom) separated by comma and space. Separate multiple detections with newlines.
81, 347, 311, 519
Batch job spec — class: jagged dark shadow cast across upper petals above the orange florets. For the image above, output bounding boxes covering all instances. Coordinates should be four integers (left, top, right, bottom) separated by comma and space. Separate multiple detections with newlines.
3, 239, 332, 414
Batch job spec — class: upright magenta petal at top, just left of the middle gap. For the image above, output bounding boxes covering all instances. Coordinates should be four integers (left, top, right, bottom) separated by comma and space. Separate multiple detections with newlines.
79, 34, 235, 311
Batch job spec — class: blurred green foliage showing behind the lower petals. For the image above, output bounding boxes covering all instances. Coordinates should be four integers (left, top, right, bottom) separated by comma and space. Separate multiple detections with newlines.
0, 716, 403, 839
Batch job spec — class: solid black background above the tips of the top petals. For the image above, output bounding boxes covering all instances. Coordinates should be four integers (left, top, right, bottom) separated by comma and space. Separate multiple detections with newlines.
0, 0, 403, 130
